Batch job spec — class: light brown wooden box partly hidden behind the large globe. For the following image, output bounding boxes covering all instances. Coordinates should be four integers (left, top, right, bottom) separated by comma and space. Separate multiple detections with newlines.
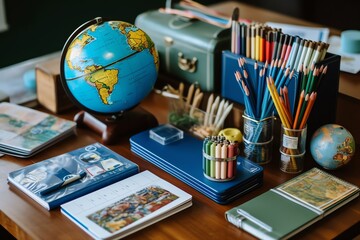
35, 57, 73, 113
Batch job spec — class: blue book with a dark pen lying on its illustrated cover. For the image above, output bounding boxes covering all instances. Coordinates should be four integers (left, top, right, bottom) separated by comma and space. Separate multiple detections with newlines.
7, 143, 139, 210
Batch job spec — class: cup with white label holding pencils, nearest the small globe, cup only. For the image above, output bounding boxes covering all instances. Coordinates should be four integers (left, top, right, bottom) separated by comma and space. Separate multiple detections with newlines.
280, 125, 307, 173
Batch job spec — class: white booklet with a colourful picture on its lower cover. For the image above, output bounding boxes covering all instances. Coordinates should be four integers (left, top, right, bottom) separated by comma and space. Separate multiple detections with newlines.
61, 170, 192, 239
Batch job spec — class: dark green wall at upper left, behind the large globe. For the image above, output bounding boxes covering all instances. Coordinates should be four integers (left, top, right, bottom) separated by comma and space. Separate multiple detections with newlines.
0, 0, 164, 68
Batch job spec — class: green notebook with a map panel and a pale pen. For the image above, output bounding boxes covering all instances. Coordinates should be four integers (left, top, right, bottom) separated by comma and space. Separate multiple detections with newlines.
225, 168, 360, 239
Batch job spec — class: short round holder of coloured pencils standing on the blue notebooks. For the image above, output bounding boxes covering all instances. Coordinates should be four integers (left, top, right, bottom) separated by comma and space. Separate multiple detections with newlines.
203, 136, 239, 182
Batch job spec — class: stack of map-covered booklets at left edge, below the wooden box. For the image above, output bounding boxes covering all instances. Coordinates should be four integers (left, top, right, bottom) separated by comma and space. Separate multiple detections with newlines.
0, 102, 76, 158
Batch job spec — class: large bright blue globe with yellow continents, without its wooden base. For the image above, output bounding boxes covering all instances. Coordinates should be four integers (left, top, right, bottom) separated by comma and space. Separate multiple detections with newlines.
60, 18, 159, 115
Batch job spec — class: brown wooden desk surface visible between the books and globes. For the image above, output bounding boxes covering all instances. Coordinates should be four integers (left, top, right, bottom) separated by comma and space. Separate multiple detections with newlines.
0, 2, 360, 239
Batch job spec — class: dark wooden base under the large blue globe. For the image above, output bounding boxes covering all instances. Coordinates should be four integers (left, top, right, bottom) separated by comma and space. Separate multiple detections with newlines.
74, 107, 158, 144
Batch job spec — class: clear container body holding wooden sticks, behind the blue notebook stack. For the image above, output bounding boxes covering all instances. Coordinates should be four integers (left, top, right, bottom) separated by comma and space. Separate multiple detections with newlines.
168, 99, 223, 139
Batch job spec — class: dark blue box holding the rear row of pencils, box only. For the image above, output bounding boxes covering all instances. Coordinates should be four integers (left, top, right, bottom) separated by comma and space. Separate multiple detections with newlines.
221, 50, 340, 141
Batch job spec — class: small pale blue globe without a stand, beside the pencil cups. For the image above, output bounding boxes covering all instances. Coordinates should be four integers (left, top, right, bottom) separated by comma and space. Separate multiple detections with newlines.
310, 124, 355, 170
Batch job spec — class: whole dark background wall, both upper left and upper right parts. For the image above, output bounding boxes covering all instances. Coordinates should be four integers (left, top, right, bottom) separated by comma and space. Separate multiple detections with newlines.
0, 0, 360, 68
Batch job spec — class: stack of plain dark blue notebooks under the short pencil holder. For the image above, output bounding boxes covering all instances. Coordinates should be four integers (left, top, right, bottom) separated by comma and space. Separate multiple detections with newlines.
130, 126, 263, 204
